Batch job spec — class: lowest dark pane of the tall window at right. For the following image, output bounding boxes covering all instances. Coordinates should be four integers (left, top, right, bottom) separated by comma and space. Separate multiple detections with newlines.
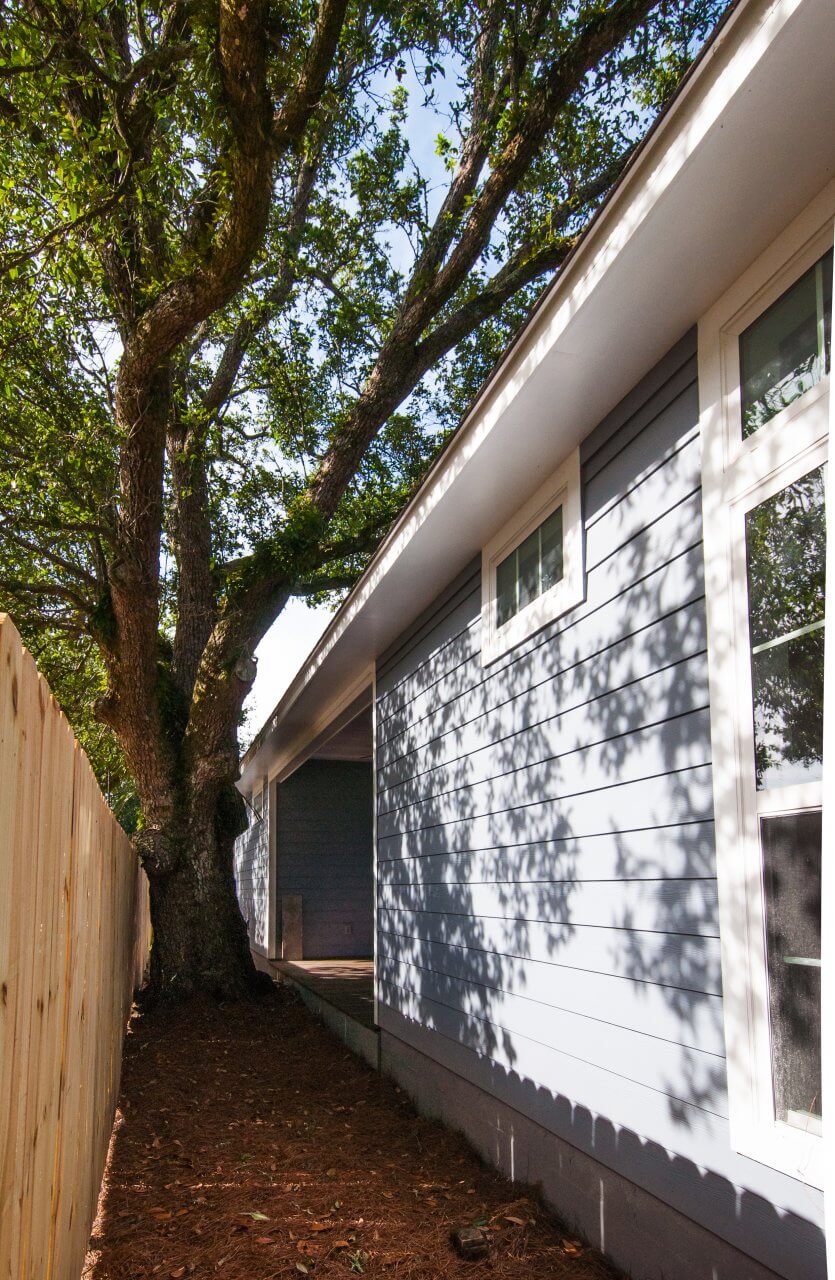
761, 810, 822, 1129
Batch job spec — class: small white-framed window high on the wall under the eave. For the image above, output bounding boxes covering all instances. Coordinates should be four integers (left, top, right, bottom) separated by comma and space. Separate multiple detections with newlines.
482, 449, 583, 663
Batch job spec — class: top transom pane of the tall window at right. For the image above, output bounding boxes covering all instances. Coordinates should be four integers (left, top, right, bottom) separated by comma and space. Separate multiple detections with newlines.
739, 250, 832, 436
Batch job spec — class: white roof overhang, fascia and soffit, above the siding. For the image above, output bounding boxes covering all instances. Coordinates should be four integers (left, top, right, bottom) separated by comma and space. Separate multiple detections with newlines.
243, 0, 835, 778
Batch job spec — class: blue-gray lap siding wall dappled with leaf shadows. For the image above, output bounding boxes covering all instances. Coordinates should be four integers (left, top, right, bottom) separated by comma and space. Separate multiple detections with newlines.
377, 334, 825, 1280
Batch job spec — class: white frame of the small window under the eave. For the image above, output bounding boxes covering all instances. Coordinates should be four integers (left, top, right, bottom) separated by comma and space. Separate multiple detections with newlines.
482, 449, 585, 666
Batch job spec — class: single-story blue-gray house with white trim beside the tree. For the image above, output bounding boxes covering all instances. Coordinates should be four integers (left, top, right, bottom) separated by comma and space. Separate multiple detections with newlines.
231, 0, 835, 1280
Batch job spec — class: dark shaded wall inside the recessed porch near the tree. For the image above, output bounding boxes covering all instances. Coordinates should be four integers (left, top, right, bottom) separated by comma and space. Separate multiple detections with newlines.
277, 760, 374, 960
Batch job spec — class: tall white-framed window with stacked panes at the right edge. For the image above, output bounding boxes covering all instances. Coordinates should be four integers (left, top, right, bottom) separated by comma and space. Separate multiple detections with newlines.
699, 197, 832, 1185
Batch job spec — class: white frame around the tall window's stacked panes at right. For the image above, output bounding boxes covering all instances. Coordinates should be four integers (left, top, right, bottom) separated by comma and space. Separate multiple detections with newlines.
699, 183, 835, 1187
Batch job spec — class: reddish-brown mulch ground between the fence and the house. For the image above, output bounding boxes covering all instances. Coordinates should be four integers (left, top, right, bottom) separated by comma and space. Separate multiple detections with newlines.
83, 991, 615, 1280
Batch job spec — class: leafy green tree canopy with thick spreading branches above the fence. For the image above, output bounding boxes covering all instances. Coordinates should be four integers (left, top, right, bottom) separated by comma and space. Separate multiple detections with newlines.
0, 0, 725, 998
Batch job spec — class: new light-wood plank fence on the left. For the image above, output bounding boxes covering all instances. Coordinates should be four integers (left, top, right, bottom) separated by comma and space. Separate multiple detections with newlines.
0, 614, 150, 1280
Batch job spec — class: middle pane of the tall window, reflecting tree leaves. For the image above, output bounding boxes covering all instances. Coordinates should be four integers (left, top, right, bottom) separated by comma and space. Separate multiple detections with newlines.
745, 467, 826, 790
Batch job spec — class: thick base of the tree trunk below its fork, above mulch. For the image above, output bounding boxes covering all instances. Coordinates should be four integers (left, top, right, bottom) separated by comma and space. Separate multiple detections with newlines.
145, 791, 263, 1001
